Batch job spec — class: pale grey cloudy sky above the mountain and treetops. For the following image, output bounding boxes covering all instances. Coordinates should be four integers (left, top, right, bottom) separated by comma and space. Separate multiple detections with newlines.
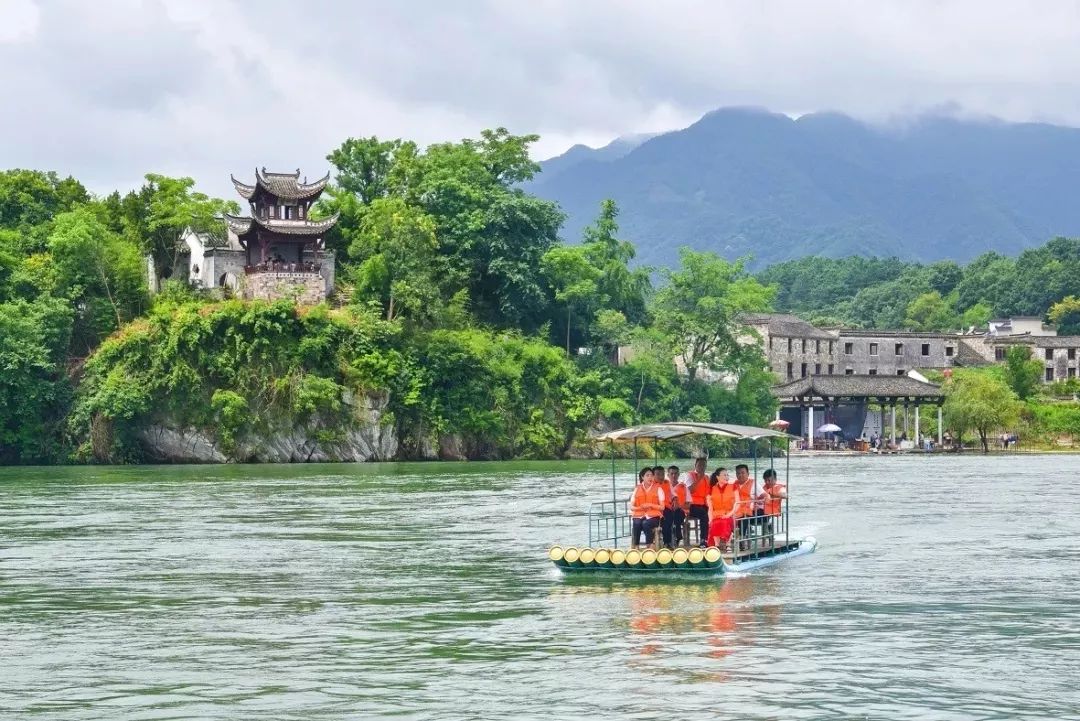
6, 0, 1080, 194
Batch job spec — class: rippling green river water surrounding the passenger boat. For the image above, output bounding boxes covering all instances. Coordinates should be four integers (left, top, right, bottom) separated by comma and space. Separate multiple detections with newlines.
0, 457, 1080, 721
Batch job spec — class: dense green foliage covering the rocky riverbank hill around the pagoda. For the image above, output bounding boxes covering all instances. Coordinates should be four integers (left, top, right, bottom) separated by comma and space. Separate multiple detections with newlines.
0, 130, 774, 463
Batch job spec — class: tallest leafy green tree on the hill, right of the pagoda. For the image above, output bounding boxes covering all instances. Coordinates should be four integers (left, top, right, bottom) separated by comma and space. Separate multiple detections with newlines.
326, 128, 563, 331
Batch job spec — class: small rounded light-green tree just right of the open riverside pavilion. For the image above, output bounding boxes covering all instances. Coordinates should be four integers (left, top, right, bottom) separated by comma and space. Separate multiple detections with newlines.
944, 371, 1022, 452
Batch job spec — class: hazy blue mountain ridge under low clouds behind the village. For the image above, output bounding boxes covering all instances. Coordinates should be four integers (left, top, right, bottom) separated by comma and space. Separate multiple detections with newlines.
529, 108, 1080, 267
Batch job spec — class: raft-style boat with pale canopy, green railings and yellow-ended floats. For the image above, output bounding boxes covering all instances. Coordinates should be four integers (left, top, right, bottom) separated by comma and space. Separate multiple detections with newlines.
548, 421, 818, 576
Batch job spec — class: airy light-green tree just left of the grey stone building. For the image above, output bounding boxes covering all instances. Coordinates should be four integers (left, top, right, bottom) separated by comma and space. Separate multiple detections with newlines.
653, 248, 774, 383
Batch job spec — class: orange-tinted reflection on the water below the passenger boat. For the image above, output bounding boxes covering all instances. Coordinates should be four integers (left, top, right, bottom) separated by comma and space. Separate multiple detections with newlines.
556, 574, 782, 680
